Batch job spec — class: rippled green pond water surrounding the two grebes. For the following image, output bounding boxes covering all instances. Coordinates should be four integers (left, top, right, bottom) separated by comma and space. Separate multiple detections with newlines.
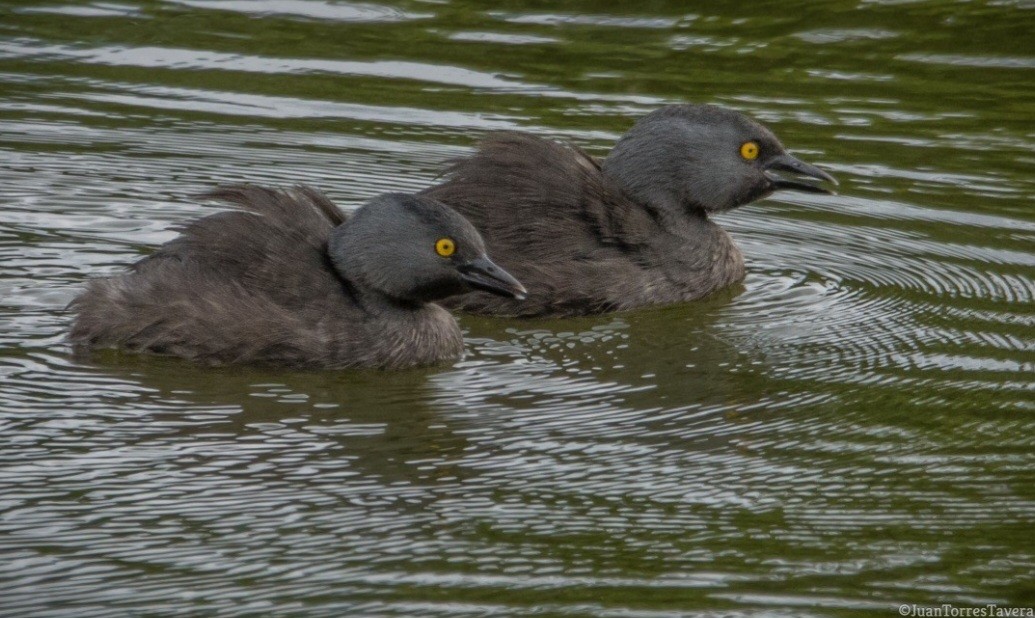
0, 0, 1035, 616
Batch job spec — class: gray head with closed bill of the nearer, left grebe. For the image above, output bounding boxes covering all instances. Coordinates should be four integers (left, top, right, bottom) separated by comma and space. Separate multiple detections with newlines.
327, 194, 526, 302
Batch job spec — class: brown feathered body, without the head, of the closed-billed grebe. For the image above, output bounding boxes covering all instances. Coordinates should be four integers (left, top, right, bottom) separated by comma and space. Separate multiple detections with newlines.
69, 185, 462, 367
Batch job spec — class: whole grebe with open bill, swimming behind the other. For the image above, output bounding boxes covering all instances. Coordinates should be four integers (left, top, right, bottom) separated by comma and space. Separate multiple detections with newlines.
422, 105, 836, 316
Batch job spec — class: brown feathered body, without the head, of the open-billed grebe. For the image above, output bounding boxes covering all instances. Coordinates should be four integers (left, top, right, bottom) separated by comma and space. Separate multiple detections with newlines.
423, 133, 744, 317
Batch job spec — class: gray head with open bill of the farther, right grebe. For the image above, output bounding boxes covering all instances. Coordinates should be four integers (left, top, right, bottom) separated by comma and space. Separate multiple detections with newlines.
603, 105, 836, 212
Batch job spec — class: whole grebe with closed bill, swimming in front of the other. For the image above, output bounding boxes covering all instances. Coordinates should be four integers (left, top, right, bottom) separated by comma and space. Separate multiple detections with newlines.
69, 185, 526, 369
